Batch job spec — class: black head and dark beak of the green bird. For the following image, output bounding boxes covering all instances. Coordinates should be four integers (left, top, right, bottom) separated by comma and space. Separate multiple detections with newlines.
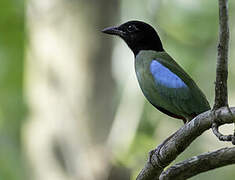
102, 21, 164, 56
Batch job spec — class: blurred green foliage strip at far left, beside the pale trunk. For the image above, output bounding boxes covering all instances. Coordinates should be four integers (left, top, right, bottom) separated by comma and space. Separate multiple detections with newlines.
0, 0, 25, 180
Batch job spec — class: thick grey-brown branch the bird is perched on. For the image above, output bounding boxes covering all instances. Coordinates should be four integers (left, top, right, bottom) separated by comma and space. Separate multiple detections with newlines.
137, 108, 235, 180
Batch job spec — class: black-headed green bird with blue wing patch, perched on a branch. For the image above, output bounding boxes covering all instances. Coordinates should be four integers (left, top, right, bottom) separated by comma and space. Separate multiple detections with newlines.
102, 20, 210, 124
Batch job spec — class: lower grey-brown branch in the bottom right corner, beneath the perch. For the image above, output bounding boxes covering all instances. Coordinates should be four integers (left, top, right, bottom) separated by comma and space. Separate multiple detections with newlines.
159, 147, 235, 180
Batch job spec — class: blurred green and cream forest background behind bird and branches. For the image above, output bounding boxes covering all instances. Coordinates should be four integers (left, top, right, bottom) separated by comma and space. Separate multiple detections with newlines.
0, 0, 235, 180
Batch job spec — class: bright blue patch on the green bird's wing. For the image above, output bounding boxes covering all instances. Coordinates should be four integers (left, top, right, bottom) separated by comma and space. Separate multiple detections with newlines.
150, 60, 187, 88
